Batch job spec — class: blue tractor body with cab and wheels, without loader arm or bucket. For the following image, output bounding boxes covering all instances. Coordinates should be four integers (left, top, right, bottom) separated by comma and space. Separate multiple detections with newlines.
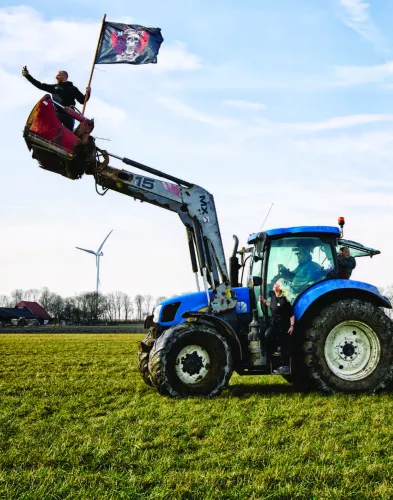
139, 221, 393, 396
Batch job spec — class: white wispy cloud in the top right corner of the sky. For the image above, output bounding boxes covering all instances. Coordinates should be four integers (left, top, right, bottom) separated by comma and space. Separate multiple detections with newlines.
339, 0, 389, 52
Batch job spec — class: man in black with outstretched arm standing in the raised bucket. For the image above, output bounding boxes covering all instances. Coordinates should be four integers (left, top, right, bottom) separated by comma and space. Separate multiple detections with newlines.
22, 66, 91, 131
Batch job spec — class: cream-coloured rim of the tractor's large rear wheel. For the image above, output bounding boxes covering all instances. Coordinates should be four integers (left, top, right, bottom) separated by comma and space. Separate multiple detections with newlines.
324, 321, 381, 381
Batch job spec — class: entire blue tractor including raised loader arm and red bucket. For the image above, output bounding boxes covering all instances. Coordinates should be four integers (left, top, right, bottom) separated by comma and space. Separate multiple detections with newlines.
24, 96, 393, 397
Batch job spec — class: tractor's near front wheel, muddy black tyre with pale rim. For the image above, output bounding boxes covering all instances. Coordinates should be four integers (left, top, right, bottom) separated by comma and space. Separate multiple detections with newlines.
149, 323, 232, 397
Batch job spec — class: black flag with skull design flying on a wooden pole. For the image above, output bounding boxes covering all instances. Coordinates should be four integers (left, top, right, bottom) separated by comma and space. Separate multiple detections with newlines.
94, 22, 164, 64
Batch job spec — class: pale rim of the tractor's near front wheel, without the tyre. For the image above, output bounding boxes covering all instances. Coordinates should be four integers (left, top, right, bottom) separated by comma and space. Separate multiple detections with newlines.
176, 345, 210, 385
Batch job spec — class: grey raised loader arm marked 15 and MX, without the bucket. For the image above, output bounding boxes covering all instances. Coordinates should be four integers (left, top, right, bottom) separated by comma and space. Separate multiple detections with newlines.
95, 151, 236, 314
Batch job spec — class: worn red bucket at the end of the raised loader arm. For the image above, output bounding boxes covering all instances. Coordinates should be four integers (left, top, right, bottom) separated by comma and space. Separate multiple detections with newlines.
23, 95, 99, 179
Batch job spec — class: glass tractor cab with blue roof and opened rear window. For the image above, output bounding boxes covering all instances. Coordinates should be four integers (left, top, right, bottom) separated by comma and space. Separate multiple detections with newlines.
248, 226, 380, 317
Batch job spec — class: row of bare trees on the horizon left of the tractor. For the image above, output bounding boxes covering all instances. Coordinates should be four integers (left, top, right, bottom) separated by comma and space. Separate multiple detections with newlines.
0, 288, 166, 324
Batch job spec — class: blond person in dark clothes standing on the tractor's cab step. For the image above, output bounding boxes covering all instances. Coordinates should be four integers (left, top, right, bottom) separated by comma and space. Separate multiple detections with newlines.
259, 279, 295, 375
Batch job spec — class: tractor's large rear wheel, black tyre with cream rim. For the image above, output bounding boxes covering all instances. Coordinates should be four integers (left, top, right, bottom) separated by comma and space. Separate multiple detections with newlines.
304, 299, 393, 393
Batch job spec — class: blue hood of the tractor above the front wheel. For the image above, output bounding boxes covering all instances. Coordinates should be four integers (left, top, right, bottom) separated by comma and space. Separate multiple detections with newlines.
153, 287, 250, 327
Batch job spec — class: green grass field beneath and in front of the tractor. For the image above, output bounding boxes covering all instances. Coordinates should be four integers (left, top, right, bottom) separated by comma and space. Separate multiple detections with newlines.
0, 334, 393, 500
